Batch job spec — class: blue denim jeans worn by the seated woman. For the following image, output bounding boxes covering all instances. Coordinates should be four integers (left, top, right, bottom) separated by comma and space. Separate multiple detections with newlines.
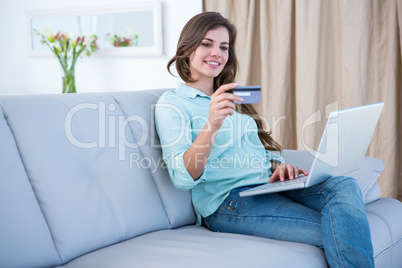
204, 177, 374, 267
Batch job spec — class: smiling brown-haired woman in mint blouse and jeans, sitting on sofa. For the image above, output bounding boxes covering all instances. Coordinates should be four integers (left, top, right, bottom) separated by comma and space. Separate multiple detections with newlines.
155, 12, 374, 267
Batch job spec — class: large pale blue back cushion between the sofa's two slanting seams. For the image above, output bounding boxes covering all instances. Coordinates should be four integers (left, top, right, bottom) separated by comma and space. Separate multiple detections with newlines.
1, 94, 169, 263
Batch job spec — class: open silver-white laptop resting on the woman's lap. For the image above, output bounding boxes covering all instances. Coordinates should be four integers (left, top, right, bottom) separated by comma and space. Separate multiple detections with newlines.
239, 102, 384, 197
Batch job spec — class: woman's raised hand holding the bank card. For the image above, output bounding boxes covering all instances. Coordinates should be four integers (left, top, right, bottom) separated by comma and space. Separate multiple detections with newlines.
208, 83, 243, 129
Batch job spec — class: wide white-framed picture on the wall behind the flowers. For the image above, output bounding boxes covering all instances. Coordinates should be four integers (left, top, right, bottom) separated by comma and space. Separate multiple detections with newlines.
27, 1, 163, 57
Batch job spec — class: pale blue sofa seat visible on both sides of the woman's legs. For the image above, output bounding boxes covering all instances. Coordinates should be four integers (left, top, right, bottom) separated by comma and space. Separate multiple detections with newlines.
61, 198, 402, 268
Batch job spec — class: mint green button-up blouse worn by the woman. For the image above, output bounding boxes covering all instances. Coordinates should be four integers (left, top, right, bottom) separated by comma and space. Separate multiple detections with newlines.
155, 84, 284, 225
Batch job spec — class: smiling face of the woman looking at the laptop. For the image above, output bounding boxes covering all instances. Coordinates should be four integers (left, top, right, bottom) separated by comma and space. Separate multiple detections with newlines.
189, 27, 229, 81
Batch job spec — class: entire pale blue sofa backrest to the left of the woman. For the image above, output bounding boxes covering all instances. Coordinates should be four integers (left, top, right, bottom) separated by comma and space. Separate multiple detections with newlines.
0, 90, 195, 267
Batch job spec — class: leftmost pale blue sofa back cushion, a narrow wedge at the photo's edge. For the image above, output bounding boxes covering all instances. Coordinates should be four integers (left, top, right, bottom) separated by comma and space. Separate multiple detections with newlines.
0, 106, 60, 267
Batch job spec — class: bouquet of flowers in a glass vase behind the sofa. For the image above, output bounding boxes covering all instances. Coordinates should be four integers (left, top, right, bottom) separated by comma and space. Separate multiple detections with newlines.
35, 26, 99, 93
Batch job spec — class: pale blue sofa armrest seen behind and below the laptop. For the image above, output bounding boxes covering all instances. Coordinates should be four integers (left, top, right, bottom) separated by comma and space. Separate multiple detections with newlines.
283, 150, 385, 204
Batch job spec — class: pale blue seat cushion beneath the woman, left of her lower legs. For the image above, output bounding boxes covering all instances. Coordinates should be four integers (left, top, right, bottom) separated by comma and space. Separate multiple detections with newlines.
62, 226, 327, 268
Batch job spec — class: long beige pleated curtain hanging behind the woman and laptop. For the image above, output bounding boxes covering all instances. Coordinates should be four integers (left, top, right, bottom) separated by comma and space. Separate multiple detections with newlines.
203, 0, 402, 199
